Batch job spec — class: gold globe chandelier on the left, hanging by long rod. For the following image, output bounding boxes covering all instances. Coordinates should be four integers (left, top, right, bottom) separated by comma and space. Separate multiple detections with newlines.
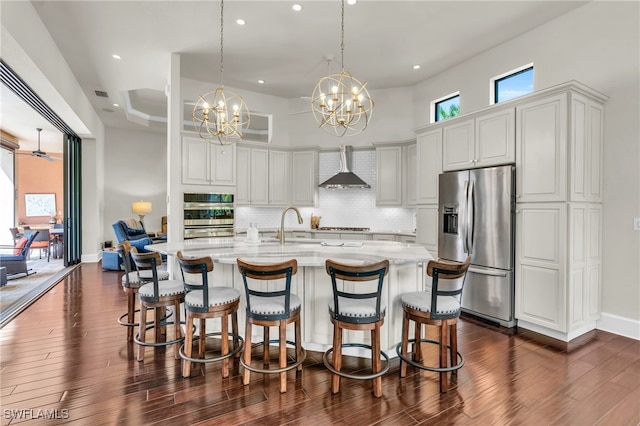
193, 0, 250, 145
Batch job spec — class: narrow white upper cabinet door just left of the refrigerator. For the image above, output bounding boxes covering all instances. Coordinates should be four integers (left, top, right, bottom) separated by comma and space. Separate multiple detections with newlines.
416, 127, 442, 204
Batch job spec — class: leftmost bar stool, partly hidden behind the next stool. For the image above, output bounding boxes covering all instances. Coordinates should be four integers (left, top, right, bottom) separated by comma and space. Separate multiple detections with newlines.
116, 240, 171, 342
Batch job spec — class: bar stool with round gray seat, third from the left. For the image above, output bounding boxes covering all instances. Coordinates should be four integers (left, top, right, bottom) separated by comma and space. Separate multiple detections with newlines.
177, 251, 243, 378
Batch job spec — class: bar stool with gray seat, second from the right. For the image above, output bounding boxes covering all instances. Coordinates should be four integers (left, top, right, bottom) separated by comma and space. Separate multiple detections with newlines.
322, 259, 389, 398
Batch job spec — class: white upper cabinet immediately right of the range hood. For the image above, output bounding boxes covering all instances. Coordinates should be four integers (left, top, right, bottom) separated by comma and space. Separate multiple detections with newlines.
376, 145, 403, 206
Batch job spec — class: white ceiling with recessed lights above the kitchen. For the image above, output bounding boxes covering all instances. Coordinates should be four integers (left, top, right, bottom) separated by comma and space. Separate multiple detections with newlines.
1, 0, 585, 151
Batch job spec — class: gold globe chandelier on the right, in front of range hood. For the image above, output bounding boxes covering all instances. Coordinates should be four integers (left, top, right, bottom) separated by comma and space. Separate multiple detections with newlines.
311, 0, 373, 137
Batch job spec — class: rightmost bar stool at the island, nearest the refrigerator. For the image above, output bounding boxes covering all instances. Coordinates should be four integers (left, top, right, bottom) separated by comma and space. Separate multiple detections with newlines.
396, 256, 471, 392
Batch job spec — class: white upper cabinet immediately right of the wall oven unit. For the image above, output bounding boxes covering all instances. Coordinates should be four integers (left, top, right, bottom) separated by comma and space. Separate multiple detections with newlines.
235, 146, 269, 206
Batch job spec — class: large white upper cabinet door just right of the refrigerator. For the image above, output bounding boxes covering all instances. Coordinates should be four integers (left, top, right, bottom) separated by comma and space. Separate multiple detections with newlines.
516, 93, 568, 203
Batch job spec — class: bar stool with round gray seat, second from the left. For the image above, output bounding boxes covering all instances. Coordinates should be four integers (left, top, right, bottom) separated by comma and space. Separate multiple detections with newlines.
131, 247, 184, 361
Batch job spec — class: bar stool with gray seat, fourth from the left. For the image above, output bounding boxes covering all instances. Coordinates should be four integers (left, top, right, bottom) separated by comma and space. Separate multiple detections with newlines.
237, 259, 307, 393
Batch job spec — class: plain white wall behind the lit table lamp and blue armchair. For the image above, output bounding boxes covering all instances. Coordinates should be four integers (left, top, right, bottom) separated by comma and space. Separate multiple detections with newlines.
103, 127, 168, 244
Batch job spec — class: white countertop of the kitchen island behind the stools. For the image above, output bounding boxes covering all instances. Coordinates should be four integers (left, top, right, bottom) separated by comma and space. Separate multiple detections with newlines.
146, 237, 432, 266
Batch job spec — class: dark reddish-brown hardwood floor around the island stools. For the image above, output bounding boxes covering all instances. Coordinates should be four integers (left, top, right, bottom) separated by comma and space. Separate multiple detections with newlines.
0, 264, 640, 426
